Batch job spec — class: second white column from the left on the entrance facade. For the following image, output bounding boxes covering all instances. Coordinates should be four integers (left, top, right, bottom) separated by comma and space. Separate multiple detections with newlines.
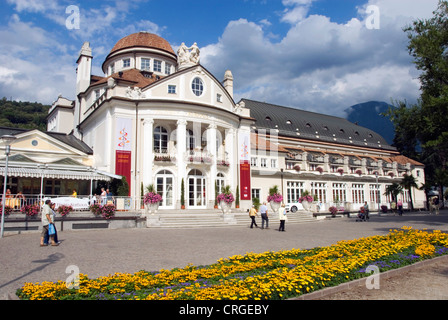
176, 119, 188, 208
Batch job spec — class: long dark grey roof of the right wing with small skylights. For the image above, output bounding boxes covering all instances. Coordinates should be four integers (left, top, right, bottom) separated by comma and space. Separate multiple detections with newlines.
242, 99, 396, 151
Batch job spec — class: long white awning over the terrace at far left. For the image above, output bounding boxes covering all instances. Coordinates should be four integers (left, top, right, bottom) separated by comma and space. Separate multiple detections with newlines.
0, 166, 121, 181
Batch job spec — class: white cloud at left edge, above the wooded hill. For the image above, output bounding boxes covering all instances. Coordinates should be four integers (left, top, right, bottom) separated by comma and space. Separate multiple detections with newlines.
0, 15, 76, 103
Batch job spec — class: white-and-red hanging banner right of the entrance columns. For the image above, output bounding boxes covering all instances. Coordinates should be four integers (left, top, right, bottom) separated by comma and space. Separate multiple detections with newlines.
238, 132, 251, 200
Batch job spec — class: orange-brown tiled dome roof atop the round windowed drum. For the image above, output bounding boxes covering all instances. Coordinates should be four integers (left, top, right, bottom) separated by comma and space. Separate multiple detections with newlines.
109, 31, 175, 55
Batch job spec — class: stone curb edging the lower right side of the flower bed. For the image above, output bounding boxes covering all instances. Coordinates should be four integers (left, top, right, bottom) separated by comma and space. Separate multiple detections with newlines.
288, 255, 448, 300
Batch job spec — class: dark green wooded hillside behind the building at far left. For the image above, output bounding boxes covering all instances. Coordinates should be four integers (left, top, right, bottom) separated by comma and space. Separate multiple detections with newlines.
0, 97, 51, 131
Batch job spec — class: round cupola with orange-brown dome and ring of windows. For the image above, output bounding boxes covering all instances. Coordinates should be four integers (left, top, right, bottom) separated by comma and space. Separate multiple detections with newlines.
102, 31, 177, 76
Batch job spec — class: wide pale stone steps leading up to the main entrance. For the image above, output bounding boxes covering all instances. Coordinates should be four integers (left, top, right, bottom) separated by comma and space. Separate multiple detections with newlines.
147, 210, 318, 228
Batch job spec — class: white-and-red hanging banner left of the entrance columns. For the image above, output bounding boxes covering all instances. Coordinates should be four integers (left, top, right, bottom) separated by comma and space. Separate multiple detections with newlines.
115, 118, 132, 195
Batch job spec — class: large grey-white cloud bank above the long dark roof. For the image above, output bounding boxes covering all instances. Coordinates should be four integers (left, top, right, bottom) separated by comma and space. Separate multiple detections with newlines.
201, 0, 437, 116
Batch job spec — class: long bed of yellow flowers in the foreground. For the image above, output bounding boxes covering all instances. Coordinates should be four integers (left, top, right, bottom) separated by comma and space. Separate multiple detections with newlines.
17, 227, 448, 300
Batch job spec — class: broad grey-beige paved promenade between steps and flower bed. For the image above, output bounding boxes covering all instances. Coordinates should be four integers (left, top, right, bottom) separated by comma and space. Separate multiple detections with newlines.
0, 211, 448, 299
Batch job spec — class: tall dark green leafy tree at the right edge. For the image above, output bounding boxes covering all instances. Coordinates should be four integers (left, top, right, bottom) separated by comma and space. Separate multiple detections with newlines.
387, 0, 448, 190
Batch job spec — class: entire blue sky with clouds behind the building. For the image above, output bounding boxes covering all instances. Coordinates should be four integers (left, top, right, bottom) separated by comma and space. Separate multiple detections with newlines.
0, 0, 438, 116
